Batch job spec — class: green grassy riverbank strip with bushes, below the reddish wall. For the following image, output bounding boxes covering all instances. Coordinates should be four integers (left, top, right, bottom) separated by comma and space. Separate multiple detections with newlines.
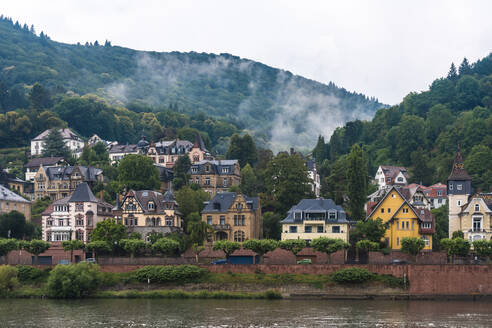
0, 263, 408, 299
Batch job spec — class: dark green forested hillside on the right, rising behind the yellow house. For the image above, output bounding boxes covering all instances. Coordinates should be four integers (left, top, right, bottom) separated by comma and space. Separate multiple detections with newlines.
314, 54, 492, 199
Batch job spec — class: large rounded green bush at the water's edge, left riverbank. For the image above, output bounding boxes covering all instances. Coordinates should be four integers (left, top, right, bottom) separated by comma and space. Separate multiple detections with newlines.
47, 263, 102, 298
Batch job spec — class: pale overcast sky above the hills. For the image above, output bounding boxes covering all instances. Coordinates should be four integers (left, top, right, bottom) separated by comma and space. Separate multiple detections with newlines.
0, 0, 492, 104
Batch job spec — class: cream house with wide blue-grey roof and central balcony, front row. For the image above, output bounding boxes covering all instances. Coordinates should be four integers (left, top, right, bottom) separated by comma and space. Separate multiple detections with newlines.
280, 198, 349, 242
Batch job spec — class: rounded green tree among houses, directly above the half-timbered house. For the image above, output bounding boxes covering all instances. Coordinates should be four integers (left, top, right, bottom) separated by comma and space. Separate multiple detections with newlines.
118, 154, 161, 190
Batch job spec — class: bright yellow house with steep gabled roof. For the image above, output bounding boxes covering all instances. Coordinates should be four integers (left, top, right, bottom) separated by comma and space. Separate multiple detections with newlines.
367, 186, 435, 251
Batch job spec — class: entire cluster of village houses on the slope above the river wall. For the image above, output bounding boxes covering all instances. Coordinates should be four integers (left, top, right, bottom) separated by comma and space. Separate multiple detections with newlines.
0, 129, 492, 262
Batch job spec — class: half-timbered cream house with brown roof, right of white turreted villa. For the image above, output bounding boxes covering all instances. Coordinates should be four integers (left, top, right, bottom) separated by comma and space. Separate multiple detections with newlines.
119, 190, 183, 240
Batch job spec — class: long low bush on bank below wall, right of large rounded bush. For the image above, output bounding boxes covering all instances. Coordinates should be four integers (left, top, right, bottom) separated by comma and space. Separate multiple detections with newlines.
135, 265, 208, 283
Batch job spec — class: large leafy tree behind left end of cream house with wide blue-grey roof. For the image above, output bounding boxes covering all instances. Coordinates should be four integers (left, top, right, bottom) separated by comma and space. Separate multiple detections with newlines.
265, 153, 313, 214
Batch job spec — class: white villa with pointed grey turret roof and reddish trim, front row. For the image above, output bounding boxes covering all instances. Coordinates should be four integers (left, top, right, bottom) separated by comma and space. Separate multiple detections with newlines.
41, 182, 113, 243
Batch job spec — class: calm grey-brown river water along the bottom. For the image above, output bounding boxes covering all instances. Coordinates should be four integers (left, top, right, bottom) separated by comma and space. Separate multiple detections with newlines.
0, 299, 492, 328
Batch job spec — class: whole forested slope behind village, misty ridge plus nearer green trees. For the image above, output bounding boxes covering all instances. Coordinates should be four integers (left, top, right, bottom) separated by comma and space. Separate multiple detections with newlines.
0, 16, 384, 151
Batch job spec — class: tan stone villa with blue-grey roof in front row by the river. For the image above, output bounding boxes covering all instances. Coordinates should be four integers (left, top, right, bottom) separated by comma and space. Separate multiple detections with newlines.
202, 192, 263, 242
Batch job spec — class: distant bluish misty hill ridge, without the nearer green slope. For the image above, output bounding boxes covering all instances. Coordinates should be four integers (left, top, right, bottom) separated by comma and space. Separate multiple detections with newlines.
0, 18, 384, 149
